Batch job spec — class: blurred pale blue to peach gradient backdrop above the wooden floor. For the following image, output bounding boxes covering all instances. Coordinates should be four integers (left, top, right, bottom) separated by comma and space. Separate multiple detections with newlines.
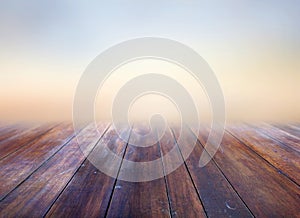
0, 0, 300, 122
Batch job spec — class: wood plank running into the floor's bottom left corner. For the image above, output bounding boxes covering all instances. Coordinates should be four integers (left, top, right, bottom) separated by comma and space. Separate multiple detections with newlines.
0, 125, 105, 217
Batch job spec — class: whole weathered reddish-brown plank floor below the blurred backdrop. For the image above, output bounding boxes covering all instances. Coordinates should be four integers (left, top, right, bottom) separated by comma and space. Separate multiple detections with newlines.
0, 123, 300, 217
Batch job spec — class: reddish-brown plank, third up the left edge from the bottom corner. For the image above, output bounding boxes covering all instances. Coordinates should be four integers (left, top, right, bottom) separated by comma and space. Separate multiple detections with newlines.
0, 124, 57, 160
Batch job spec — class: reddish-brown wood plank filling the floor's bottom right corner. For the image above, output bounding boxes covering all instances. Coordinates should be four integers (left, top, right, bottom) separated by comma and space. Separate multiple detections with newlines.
195, 125, 300, 217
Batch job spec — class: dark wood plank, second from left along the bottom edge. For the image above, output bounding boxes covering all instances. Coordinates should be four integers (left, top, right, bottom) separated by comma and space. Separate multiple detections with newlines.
47, 125, 129, 217
